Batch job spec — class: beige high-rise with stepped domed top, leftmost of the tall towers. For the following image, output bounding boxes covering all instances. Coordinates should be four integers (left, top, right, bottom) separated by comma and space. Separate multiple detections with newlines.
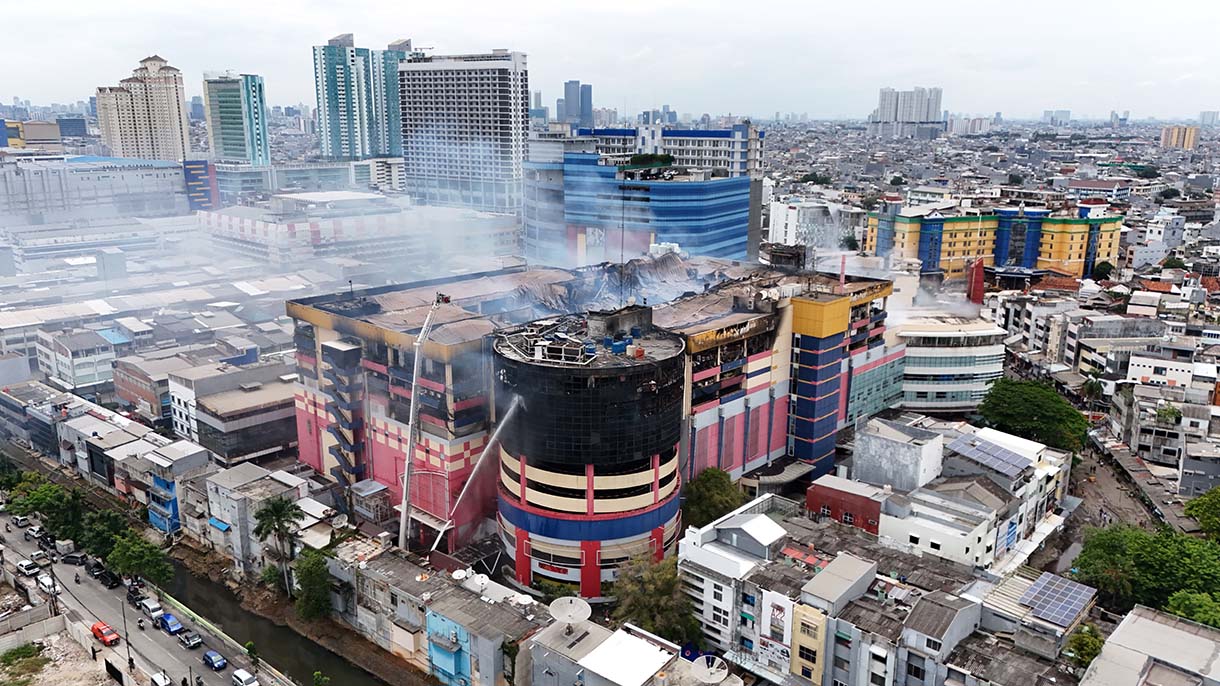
98, 55, 190, 161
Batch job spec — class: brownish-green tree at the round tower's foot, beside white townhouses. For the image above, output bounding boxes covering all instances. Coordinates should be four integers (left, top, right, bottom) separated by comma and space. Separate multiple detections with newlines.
614, 555, 700, 646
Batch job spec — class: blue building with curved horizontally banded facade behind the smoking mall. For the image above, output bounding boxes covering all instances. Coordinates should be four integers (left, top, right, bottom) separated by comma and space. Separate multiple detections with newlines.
526, 153, 750, 265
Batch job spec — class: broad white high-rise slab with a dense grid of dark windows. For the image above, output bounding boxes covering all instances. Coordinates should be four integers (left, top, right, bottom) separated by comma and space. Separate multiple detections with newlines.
398, 50, 529, 214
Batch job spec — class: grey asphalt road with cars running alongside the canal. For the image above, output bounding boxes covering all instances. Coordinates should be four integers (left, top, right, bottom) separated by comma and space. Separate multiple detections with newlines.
0, 514, 259, 686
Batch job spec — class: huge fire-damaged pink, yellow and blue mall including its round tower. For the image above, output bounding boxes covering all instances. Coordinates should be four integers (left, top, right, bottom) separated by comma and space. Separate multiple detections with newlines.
288, 255, 903, 585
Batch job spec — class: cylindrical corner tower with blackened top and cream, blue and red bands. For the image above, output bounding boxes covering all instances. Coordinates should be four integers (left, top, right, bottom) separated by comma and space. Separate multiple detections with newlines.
494, 306, 684, 597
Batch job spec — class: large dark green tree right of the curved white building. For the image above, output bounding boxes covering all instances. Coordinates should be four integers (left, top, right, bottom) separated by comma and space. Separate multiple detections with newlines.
978, 378, 1088, 450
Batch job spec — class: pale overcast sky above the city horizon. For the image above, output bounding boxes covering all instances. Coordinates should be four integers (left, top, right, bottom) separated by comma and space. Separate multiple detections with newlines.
9, 0, 1220, 118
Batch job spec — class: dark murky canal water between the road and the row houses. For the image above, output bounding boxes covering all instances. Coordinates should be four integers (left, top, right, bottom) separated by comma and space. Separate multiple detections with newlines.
166, 563, 386, 686
